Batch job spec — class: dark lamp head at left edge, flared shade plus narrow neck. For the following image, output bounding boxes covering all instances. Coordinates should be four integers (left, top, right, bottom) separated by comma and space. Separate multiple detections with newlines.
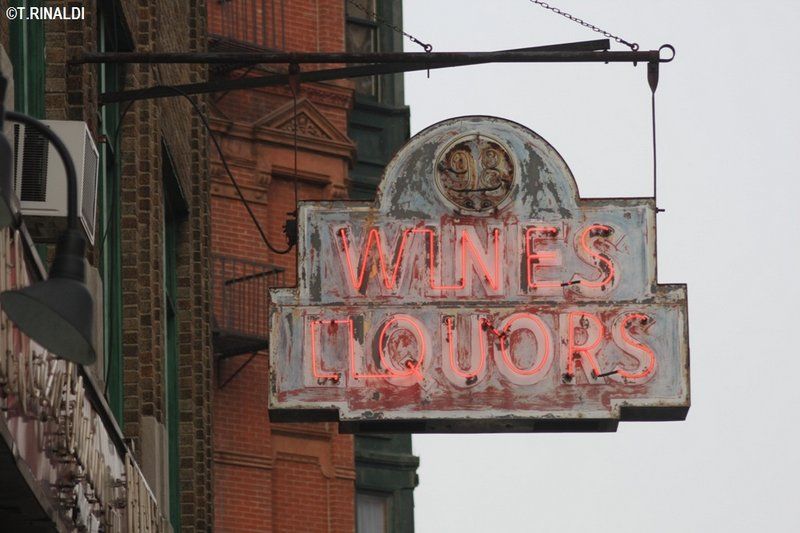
0, 229, 97, 365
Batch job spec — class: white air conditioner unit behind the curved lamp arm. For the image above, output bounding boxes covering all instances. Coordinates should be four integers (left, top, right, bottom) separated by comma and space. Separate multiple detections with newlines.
14, 120, 100, 245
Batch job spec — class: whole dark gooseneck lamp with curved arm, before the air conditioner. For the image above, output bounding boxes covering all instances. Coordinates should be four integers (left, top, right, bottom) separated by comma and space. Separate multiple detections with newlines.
0, 79, 97, 365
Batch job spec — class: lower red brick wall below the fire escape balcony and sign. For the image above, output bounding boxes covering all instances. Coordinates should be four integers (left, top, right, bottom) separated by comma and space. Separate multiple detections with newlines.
214, 354, 355, 533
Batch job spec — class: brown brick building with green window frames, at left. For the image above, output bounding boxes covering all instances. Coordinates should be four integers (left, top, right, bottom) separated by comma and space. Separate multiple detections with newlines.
0, 0, 213, 531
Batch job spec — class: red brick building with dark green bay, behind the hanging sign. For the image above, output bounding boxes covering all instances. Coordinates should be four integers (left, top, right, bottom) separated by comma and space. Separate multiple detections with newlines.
209, 0, 418, 533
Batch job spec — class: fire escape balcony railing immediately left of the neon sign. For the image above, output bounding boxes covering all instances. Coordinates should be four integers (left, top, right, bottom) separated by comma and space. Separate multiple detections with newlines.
212, 254, 285, 340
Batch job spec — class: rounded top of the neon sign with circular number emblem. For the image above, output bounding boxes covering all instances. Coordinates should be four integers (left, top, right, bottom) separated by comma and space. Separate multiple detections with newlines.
377, 116, 578, 218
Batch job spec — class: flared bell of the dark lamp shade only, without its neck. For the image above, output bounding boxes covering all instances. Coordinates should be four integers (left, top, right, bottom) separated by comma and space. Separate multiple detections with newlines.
0, 278, 96, 365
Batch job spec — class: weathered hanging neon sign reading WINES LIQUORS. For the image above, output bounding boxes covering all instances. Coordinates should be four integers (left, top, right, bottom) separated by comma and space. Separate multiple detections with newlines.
270, 117, 689, 431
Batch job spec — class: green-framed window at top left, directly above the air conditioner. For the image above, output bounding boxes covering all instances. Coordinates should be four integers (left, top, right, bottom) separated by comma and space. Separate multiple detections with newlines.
9, 0, 45, 119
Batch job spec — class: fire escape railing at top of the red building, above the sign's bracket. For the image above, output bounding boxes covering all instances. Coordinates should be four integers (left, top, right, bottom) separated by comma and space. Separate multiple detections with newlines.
208, 0, 286, 50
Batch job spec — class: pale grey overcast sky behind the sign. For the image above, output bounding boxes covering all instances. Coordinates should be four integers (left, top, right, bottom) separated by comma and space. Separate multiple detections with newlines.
404, 0, 800, 533
